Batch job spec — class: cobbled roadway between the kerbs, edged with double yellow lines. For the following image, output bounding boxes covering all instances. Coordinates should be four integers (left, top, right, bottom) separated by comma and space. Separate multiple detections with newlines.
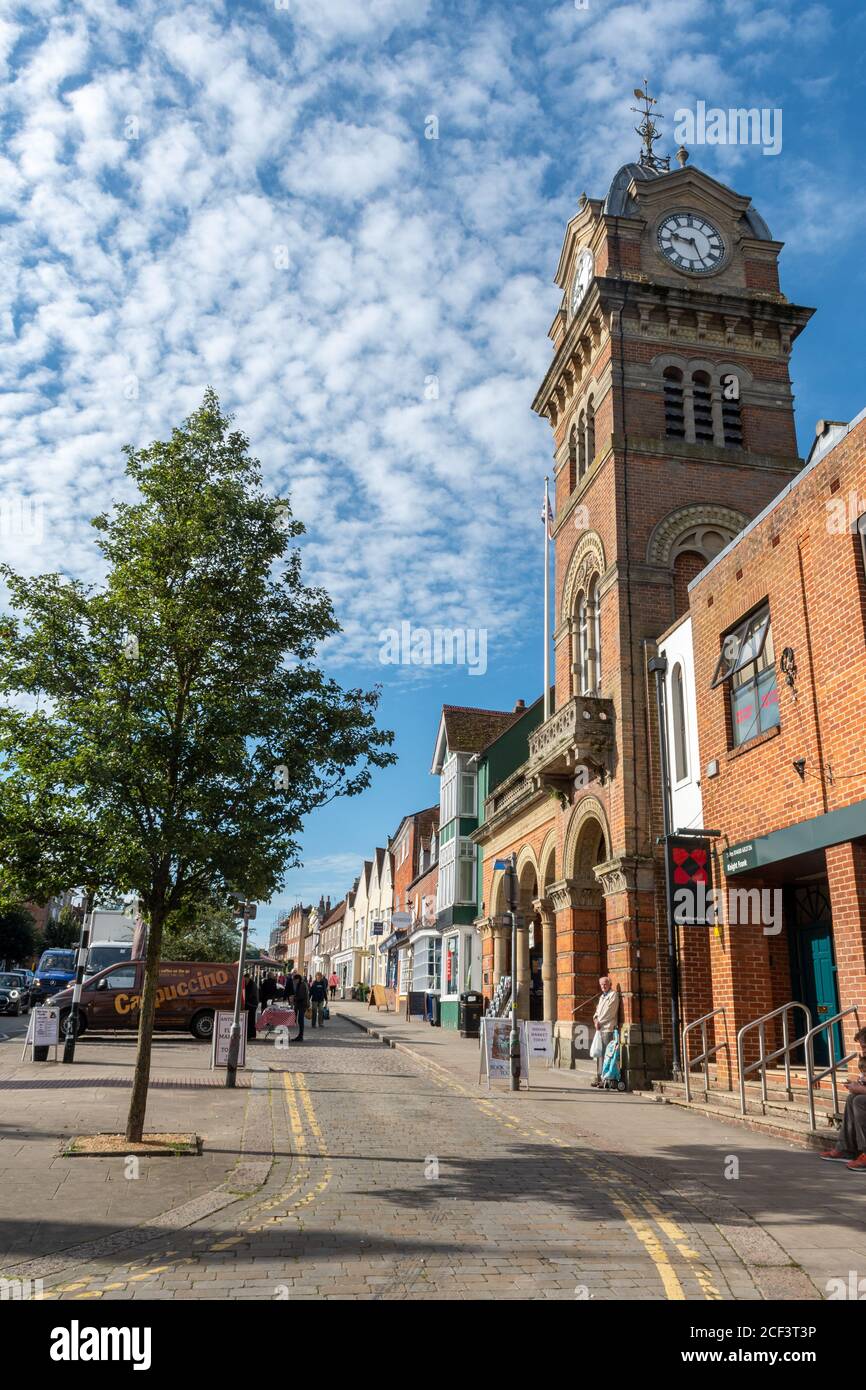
35, 1017, 783, 1301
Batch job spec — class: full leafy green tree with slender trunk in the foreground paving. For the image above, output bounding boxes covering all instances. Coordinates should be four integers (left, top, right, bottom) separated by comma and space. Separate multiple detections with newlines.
0, 389, 395, 1141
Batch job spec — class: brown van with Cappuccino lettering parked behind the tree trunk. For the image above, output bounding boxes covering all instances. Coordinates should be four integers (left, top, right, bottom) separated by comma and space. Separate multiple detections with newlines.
50, 960, 238, 1040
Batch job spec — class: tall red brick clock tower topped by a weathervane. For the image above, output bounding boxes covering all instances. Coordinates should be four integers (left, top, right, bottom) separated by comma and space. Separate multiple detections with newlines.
531, 93, 813, 1079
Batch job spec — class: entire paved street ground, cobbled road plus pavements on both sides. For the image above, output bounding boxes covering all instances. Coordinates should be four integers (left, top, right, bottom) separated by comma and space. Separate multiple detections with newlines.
0, 1004, 866, 1302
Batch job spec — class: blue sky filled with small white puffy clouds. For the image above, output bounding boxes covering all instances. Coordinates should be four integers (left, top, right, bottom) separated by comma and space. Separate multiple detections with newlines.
0, 0, 866, 930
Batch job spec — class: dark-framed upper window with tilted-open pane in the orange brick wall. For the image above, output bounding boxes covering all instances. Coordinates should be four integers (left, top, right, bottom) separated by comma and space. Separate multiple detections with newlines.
713, 603, 778, 748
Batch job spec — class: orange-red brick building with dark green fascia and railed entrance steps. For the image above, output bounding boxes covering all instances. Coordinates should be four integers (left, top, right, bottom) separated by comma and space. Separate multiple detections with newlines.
670, 411, 866, 1059
